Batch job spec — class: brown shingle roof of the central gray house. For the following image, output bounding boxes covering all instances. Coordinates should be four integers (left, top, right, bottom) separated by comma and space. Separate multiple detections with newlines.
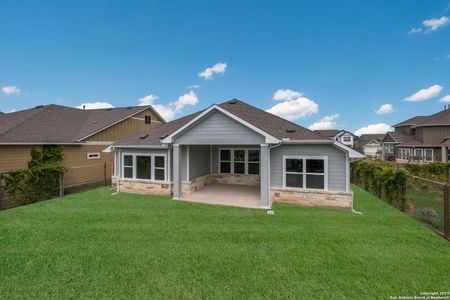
115, 99, 327, 146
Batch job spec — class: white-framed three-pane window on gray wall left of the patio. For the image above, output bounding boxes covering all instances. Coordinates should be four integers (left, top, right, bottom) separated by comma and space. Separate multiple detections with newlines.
122, 153, 167, 181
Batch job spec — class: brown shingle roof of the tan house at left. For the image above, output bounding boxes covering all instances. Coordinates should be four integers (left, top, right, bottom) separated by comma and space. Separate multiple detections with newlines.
0, 104, 156, 143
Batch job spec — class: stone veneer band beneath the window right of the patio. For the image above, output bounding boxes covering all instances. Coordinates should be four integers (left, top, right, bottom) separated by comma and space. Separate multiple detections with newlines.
270, 188, 353, 210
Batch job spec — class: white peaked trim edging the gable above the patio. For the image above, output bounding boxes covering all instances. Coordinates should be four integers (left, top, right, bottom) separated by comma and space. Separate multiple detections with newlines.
161, 104, 280, 144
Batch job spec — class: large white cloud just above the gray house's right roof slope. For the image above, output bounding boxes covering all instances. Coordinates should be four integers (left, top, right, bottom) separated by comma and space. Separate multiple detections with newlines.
266, 97, 319, 121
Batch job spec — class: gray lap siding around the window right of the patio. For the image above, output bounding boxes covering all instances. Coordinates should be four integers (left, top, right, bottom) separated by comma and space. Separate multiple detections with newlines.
270, 145, 347, 191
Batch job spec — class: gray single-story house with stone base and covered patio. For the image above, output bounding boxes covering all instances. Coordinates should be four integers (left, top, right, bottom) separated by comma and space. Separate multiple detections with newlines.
111, 100, 363, 209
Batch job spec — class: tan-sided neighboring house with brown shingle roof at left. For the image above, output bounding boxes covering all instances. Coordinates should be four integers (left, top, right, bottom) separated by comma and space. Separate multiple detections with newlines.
0, 104, 165, 187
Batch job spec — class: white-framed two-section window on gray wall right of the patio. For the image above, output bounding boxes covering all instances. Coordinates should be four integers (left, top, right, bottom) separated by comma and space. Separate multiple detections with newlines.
283, 155, 328, 190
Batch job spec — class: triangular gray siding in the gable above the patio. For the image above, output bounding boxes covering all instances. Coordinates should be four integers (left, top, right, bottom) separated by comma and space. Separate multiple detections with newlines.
174, 111, 265, 145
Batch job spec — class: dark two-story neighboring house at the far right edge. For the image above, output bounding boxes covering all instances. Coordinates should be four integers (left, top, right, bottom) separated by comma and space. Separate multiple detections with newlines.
382, 106, 450, 163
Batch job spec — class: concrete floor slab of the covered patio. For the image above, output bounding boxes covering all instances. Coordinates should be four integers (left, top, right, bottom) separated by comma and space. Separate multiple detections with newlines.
180, 183, 261, 208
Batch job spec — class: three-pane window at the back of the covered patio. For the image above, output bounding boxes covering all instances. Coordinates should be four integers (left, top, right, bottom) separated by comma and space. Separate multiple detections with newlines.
219, 148, 260, 175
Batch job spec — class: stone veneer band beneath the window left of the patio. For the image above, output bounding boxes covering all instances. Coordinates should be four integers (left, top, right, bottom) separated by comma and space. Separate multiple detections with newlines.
112, 178, 172, 196
